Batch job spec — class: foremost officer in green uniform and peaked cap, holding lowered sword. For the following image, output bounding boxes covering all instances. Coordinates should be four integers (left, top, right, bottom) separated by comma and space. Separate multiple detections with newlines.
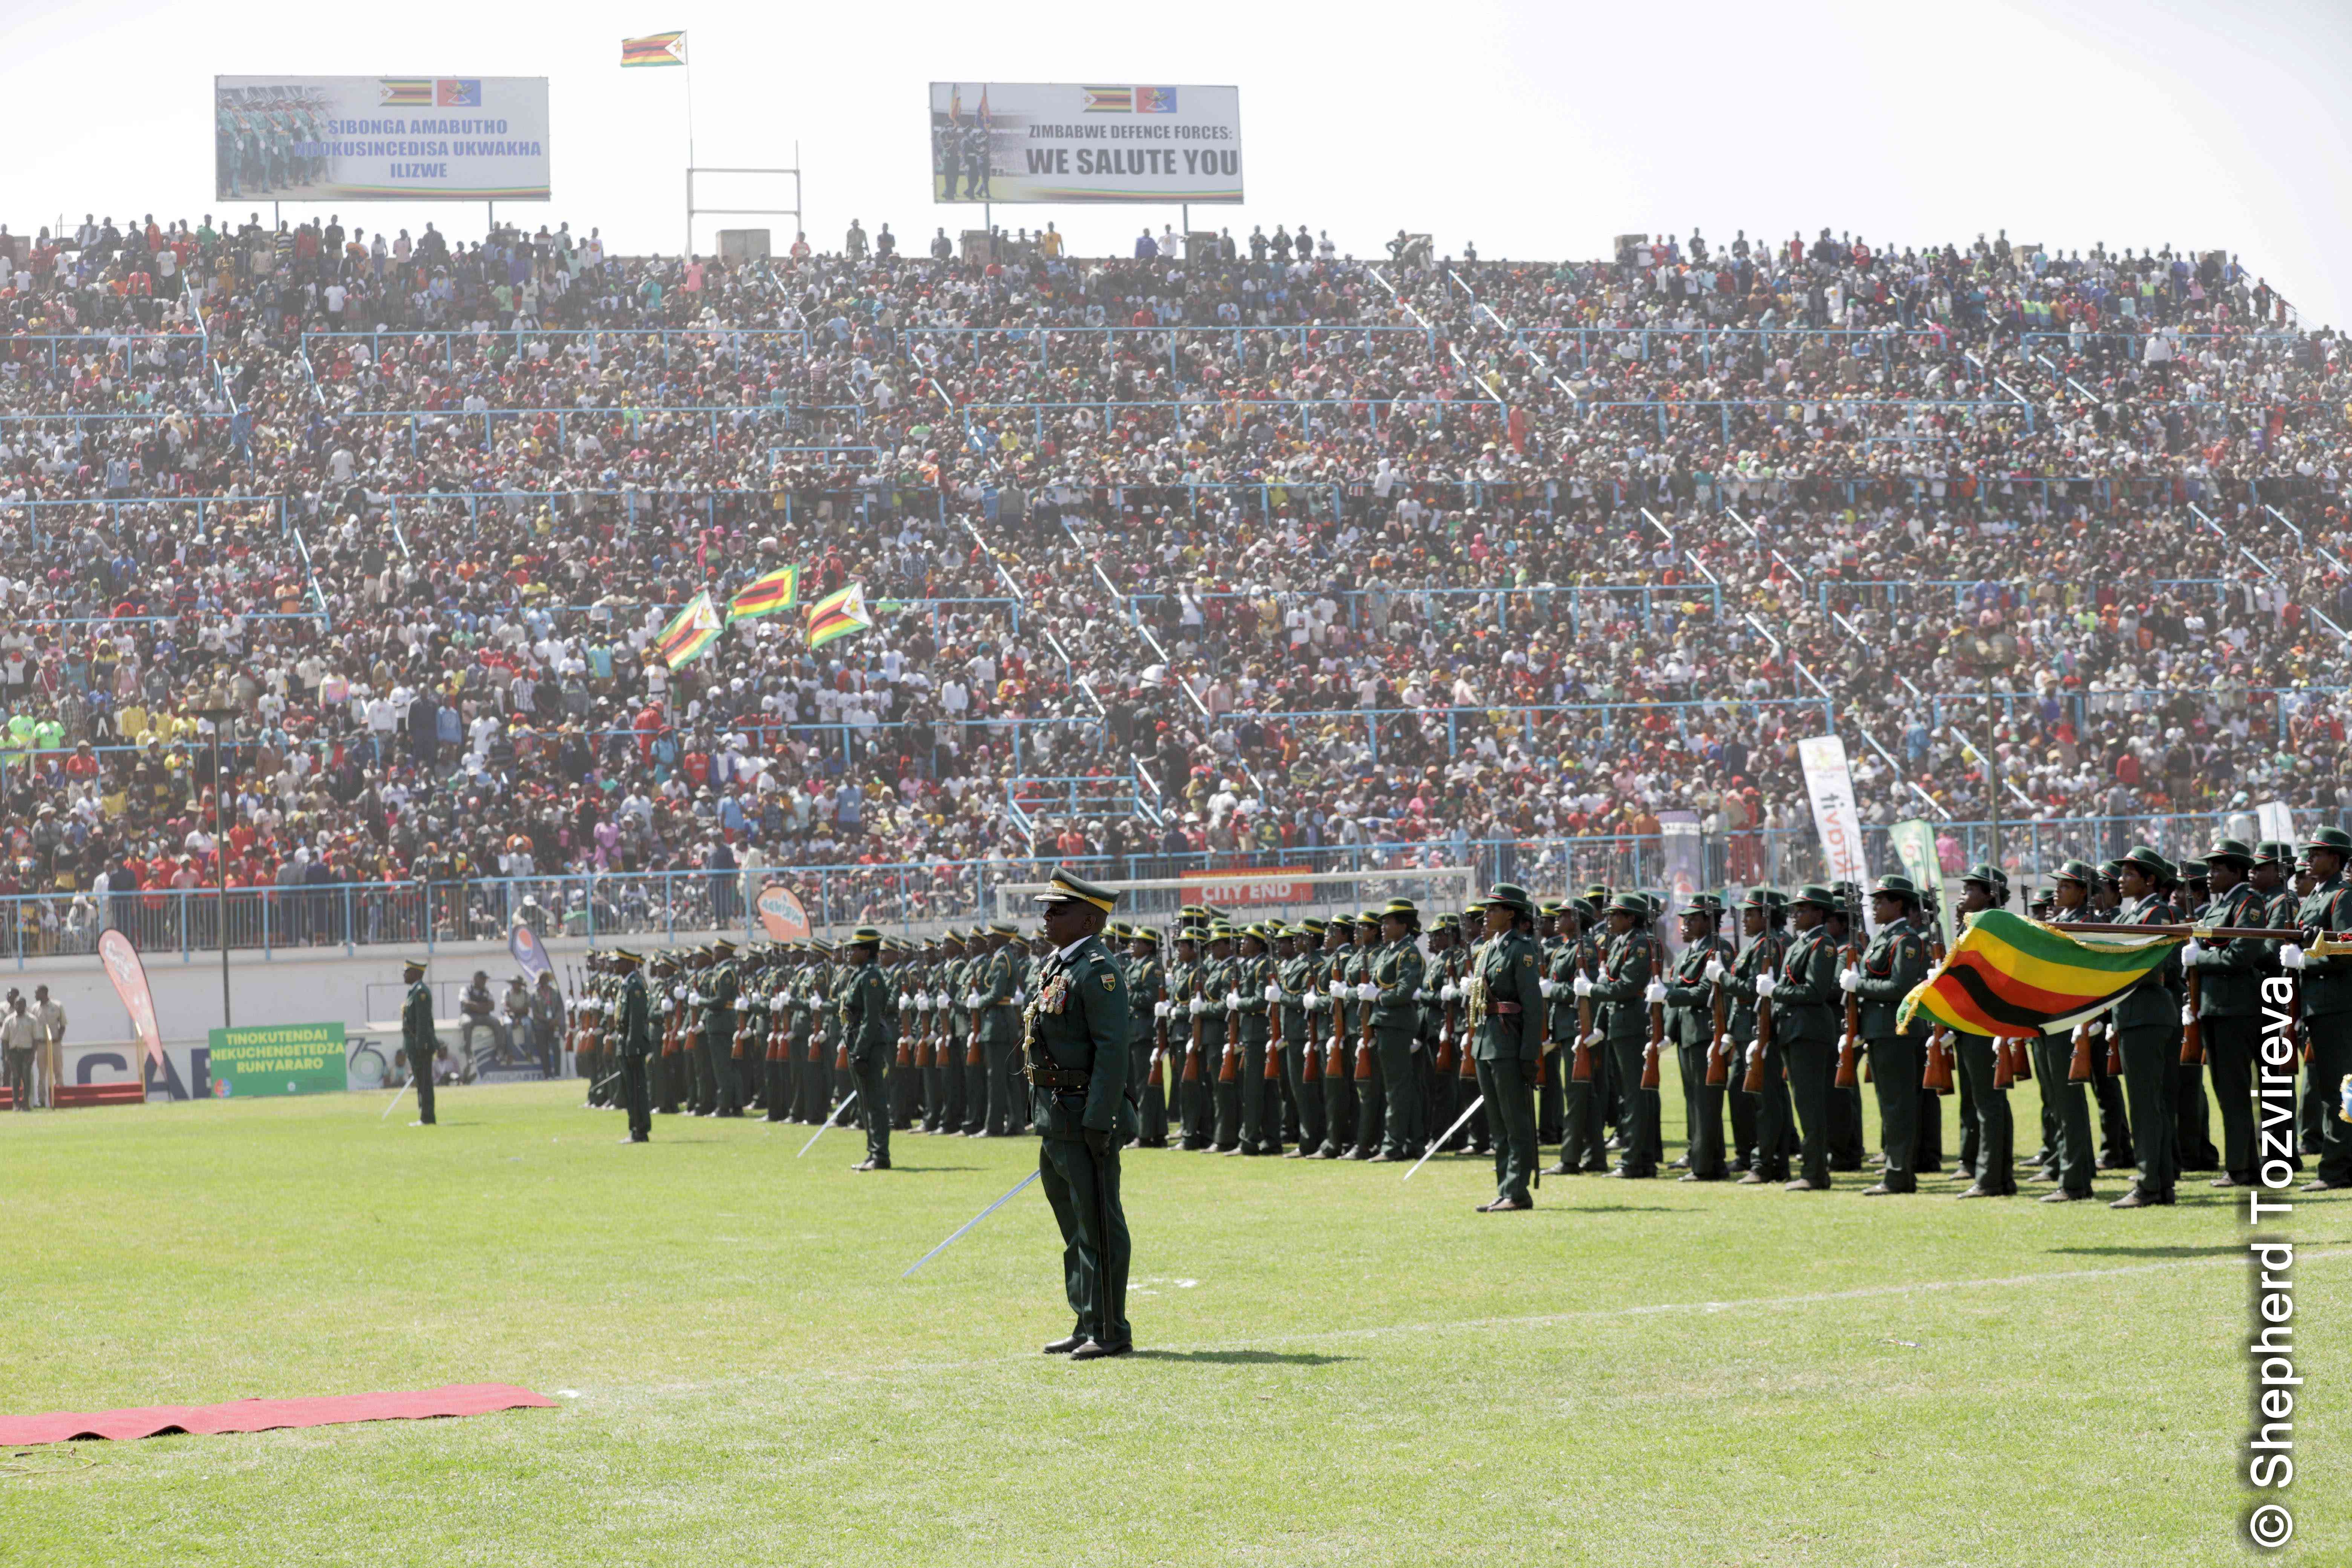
1021, 867, 1136, 1361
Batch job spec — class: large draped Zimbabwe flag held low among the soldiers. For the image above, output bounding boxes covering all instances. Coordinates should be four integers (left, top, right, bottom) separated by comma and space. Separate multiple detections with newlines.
1896, 910, 2187, 1037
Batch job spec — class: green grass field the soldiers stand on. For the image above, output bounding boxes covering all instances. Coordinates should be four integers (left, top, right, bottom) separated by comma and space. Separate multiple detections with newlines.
0, 1084, 2352, 1568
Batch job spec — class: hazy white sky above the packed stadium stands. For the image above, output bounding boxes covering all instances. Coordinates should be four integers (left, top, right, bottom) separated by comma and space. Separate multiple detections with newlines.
0, 0, 2352, 322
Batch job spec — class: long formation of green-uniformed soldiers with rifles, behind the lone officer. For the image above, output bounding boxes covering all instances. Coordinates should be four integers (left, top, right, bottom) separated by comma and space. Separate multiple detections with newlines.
545, 830, 2352, 1208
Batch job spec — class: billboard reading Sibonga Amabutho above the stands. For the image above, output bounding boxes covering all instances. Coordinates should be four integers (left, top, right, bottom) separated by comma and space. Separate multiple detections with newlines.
212, 75, 548, 202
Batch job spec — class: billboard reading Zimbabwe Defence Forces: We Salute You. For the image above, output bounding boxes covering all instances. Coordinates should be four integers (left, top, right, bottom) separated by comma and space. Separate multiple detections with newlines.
931, 82, 1242, 205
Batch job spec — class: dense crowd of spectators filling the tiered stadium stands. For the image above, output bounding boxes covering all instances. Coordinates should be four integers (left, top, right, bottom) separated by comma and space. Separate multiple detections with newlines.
0, 216, 2352, 943
